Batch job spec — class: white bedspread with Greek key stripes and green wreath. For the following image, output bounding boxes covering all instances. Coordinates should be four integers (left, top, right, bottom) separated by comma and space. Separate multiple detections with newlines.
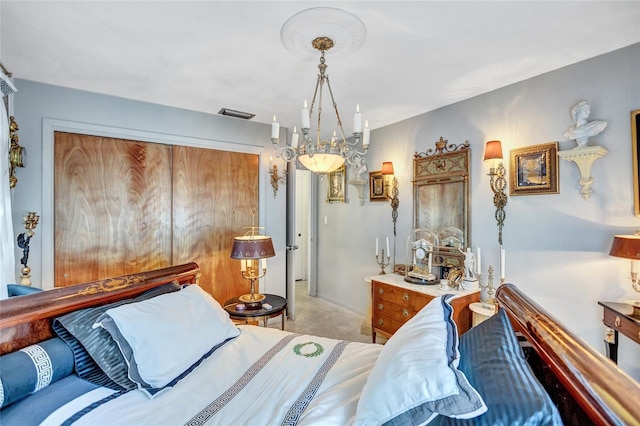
44, 326, 382, 426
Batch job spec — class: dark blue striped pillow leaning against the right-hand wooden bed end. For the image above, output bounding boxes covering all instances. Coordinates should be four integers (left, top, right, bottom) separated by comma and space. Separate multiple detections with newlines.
438, 309, 562, 426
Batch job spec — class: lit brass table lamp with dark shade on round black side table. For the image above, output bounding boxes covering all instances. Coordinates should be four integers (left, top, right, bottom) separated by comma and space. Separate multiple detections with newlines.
231, 233, 276, 309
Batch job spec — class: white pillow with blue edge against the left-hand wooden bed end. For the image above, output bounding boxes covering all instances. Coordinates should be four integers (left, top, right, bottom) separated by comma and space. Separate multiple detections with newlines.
94, 285, 240, 394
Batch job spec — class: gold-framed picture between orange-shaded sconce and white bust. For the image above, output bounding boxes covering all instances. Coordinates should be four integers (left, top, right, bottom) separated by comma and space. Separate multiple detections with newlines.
509, 142, 558, 195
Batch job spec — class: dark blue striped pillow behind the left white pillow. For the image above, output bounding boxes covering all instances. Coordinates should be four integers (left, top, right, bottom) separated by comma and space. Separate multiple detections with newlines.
52, 281, 181, 390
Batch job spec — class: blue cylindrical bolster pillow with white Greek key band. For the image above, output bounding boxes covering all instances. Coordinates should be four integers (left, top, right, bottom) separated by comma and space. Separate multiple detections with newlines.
0, 338, 73, 408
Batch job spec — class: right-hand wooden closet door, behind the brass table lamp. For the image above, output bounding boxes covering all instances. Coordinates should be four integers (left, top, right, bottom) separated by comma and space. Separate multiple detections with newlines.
173, 146, 259, 303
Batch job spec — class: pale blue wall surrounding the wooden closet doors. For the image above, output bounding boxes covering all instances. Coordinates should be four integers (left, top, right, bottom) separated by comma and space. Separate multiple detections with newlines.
12, 79, 286, 295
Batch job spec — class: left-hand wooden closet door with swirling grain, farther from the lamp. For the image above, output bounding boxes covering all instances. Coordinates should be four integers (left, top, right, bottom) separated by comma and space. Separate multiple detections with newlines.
54, 132, 172, 287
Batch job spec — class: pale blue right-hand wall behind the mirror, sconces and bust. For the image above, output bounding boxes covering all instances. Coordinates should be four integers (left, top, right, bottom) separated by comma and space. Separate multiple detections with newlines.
318, 45, 640, 380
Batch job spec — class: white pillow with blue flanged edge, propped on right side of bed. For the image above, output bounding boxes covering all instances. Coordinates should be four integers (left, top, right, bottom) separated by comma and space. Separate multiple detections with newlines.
355, 295, 487, 425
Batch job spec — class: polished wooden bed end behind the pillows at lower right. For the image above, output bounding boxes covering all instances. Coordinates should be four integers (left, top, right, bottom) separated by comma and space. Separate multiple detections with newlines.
496, 284, 640, 425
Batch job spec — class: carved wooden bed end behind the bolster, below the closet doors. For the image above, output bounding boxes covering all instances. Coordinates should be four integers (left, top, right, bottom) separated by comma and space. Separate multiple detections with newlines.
0, 263, 200, 355
